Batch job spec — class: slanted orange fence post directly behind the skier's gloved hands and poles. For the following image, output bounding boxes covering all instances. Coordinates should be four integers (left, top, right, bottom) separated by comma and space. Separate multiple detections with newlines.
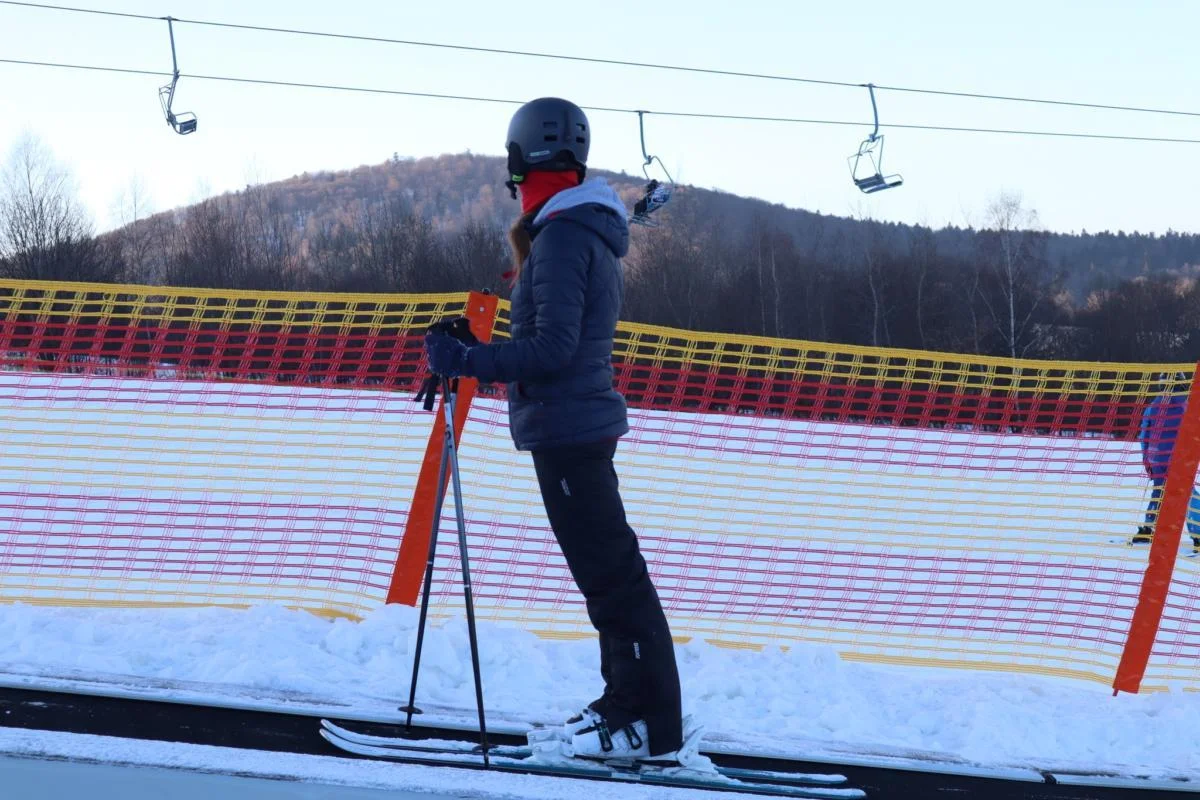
385, 291, 498, 606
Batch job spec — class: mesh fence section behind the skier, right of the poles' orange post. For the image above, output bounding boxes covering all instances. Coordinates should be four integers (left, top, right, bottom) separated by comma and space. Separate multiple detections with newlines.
434, 299, 1200, 686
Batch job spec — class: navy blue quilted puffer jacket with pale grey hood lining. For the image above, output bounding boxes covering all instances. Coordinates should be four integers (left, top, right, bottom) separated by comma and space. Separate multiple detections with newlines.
466, 179, 629, 450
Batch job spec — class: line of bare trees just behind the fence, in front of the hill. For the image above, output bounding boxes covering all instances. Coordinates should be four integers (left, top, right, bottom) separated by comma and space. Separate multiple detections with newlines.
0, 137, 1200, 362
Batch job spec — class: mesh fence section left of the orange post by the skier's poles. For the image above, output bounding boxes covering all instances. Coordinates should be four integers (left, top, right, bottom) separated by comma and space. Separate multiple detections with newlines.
0, 282, 466, 613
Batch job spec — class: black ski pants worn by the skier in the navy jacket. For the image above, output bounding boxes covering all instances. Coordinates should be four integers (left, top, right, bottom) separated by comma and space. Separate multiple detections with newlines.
533, 439, 683, 756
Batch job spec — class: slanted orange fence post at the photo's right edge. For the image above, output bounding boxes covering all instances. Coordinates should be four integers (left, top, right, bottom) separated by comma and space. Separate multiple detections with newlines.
1112, 365, 1200, 694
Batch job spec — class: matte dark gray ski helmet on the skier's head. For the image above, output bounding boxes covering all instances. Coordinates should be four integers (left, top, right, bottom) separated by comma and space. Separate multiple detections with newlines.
506, 97, 592, 196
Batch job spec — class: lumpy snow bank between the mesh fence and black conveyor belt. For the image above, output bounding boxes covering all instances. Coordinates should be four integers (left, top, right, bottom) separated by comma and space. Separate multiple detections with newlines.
0, 604, 1200, 780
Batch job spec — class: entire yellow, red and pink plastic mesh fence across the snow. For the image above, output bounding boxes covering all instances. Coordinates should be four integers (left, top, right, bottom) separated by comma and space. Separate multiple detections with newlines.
0, 282, 1200, 687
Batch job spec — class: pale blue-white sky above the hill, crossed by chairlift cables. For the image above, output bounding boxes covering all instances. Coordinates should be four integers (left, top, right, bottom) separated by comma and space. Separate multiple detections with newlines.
0, 0, 1200, 233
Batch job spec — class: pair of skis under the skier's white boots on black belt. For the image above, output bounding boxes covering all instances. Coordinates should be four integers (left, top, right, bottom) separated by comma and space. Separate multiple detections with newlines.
320, 720, 866, 800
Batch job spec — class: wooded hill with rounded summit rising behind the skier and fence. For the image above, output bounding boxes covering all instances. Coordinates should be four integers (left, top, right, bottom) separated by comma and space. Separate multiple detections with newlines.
11, 154, 1200, 361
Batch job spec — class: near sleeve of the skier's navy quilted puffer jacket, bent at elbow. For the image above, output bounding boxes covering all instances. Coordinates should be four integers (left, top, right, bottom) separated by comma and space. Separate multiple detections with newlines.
466, 221, 590, 383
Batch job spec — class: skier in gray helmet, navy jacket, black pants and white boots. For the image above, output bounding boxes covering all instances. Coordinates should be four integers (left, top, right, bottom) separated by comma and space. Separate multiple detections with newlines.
426, 97, 683, 762
